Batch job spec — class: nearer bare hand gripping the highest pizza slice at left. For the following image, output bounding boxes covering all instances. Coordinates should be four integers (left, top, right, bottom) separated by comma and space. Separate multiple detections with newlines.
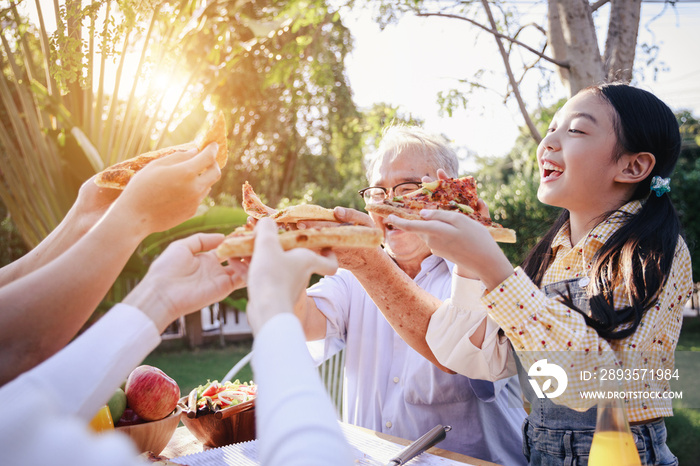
108, 144, 221, 236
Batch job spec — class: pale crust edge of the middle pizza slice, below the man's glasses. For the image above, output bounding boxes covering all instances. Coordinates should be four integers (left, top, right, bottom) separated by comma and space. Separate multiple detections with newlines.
216, 225, 383, 260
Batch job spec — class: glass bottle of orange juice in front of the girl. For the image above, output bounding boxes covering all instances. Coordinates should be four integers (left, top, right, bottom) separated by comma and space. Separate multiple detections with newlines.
588, 371, 642, 466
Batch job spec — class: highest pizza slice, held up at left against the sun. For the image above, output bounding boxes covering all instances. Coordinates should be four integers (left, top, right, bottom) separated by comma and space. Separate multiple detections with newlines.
95, 112, 228, 189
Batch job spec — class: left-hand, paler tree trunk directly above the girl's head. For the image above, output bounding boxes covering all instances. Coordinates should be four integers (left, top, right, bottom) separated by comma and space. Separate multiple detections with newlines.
547, 0, 605, 97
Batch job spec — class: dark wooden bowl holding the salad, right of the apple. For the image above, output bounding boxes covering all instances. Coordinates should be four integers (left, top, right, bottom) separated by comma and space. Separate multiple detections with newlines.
180, 397, 255, 448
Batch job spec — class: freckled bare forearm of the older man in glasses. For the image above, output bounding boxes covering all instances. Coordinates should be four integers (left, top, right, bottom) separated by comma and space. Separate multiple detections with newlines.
353, 249, 453, 372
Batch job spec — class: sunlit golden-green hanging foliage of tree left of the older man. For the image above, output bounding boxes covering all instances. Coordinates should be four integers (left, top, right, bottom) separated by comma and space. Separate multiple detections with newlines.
201, 1, 362, 205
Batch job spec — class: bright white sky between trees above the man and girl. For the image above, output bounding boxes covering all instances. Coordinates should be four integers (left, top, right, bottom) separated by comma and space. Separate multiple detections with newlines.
343, 0, 700, 166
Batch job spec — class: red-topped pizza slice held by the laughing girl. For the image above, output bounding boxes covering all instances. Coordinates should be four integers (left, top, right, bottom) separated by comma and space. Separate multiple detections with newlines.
365, 176, 516, 243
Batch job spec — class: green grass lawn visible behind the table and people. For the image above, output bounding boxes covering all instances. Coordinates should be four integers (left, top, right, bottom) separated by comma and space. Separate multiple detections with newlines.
144, 318, 700, 465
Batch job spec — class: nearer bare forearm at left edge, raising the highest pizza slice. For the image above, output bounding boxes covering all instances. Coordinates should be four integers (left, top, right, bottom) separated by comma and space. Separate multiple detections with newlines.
0, 213, 144, 384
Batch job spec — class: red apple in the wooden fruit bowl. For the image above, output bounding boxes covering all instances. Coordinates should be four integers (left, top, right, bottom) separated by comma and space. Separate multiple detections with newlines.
124, 365, 180, 421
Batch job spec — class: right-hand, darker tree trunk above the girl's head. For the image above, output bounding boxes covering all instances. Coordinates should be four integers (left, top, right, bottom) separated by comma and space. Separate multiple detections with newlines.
605, 0, 642, 83
